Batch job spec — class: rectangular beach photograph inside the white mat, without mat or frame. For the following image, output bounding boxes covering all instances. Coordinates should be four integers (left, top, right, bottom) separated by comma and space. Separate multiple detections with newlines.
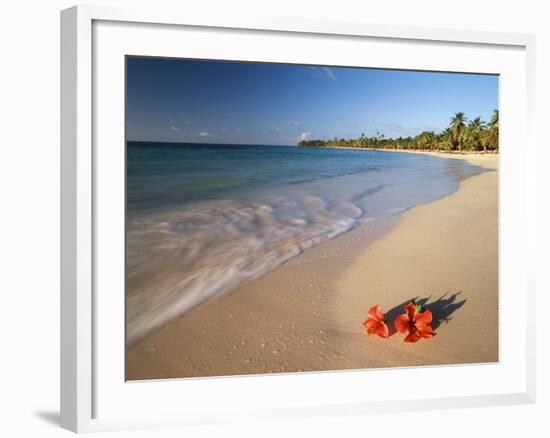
125, 56, 499, 381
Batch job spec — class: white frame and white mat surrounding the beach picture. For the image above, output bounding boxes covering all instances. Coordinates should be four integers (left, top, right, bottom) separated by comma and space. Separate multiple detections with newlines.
61, 6, 536, 432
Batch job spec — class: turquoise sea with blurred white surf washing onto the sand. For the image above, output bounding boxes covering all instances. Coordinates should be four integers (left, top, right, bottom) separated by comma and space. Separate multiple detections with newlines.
127, 142, 479, 344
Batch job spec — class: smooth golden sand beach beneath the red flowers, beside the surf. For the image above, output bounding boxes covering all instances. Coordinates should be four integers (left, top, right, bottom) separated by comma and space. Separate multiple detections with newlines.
127, 154, 498, 380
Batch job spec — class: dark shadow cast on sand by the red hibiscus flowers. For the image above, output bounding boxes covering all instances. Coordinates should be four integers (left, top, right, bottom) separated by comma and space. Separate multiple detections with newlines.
385, 292, 466, 336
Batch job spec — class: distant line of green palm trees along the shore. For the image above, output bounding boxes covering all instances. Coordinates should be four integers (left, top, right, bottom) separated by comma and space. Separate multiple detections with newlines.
298, 110, 499, 152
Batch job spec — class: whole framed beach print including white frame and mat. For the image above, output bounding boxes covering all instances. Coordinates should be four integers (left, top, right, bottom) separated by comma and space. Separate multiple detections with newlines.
61, 7, 535, 431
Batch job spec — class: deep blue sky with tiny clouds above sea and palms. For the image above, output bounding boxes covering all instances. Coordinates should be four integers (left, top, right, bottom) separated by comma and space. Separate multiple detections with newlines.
126, 58, 498, 145
